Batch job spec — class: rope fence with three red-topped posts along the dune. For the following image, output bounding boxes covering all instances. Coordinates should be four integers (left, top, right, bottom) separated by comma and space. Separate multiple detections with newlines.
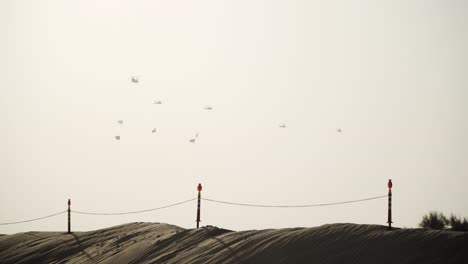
0, 180, 392, 233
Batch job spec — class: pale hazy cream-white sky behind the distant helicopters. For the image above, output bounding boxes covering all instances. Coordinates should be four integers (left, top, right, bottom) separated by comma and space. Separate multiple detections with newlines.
0, 0, 468, 233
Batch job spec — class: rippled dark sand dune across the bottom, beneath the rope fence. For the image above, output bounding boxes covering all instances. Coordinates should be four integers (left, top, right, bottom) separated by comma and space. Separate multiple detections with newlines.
0, 223, 468, 264
